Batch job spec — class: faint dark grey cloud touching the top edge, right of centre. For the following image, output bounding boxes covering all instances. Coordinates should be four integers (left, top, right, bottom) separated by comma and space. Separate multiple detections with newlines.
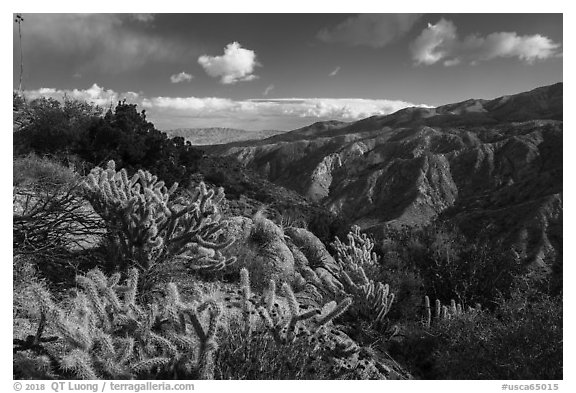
317, 14, 422, 48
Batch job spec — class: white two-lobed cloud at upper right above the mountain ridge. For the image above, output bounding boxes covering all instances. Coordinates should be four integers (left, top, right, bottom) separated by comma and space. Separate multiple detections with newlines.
411, 19, 561, 66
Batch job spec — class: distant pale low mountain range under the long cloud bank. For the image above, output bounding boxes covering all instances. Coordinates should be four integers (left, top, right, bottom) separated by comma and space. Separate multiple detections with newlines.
164, 127, 284, 145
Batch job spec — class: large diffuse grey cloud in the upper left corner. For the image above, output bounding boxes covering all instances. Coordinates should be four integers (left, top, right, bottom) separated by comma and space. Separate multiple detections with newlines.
14, 14, 192, 73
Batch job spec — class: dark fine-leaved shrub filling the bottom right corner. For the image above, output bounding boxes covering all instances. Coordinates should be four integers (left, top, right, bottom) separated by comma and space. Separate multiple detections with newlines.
434, 286, 563, 379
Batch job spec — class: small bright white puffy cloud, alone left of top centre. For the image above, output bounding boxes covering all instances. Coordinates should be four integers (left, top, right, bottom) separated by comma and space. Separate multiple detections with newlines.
198, 42, 260, 85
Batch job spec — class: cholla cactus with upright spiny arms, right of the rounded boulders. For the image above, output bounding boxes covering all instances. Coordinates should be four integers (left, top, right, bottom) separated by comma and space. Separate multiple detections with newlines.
332, 226, 394, 324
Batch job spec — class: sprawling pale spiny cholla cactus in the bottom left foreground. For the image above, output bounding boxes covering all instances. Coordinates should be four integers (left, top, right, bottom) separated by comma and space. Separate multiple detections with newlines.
22, 269, 221, 379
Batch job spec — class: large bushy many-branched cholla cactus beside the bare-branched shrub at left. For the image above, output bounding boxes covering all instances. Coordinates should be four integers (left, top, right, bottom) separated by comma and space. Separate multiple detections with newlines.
84, 161, 235, 270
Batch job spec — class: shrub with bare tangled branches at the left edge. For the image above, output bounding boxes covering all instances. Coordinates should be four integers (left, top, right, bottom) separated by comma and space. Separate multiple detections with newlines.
12, 155, 103, 264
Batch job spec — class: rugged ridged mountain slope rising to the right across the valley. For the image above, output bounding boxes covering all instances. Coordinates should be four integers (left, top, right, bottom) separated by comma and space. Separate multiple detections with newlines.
207, 83, 563, 269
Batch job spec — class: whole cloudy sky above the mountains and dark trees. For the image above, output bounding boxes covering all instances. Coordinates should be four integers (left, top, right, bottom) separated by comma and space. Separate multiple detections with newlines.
13, 13, 563, 130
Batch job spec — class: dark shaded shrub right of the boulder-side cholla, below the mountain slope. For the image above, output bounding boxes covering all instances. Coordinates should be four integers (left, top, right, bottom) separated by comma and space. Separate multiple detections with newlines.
379, 224, 523, 308
